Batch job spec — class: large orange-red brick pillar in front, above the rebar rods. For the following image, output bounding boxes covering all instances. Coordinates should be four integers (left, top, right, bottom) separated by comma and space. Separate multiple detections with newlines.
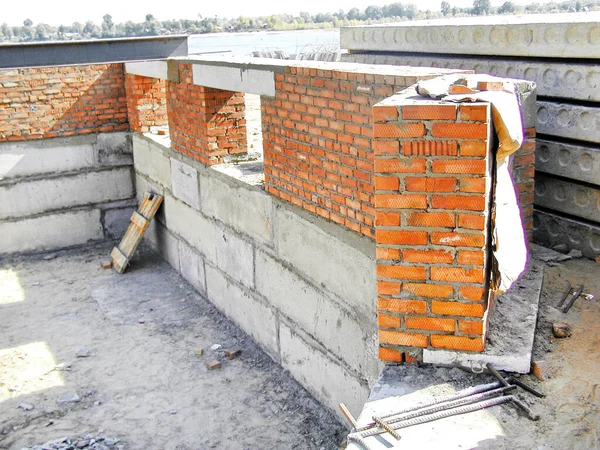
373, 94, 493, 362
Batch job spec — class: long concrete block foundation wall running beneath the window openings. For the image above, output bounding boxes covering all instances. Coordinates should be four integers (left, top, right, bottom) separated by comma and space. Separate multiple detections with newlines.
133, 133, 379, 420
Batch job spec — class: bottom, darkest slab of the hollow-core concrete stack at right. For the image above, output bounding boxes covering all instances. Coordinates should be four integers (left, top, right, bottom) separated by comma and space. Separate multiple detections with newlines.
533, 211, 600, 259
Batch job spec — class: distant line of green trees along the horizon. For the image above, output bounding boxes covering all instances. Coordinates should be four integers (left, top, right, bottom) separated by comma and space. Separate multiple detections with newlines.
0, 0, 600, 43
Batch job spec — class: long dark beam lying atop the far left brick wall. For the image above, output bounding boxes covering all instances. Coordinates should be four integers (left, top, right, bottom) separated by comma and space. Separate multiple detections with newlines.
0, 36, 188, 69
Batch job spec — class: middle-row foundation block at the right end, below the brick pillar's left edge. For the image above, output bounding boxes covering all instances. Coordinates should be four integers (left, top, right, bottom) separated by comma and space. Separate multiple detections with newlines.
256, 251, 378, 379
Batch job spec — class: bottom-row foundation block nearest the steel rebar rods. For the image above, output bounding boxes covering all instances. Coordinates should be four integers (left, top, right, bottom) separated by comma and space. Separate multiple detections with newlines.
279, 323, 369, 420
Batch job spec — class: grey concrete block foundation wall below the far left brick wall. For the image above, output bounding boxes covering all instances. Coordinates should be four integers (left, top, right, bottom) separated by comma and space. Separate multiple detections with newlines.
0, 132, 135, 254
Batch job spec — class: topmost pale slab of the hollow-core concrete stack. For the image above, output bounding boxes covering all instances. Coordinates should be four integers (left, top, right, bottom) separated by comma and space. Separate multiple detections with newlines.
340, 12, 600, 58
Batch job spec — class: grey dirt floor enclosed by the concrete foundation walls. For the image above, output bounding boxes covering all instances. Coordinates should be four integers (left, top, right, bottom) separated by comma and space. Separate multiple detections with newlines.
0, 245, 345, 450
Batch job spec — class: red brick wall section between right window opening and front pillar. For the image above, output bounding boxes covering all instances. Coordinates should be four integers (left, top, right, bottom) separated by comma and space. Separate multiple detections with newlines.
261, 67, 428, 236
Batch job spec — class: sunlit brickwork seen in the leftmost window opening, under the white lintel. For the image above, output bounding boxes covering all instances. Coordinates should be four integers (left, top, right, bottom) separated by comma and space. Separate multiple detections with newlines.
125, 74, 168, 133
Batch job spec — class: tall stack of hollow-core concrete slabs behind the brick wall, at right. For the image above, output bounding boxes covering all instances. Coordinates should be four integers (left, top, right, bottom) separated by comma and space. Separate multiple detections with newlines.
341, 12, 600, 257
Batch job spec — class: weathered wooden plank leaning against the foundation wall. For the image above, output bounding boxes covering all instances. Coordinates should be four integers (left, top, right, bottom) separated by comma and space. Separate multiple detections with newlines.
110, 192, 163, 273
